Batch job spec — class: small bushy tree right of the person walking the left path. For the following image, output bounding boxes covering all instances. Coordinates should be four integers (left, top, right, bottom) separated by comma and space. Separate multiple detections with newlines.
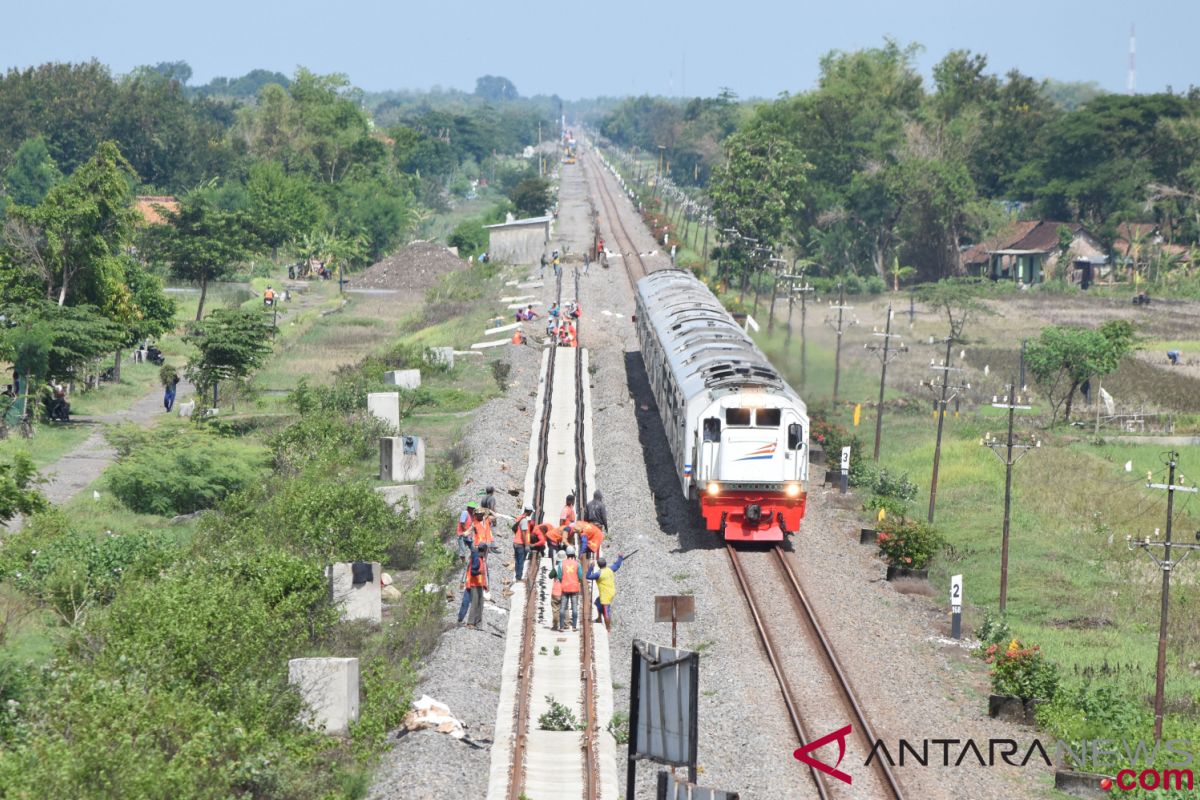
184, 308, 271, 404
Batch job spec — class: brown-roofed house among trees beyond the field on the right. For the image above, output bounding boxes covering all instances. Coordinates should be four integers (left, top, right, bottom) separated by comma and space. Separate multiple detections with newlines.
962, 219, 1108, 289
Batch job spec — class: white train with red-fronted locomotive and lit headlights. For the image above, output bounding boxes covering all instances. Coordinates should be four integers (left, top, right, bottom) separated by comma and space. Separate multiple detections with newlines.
634, 270, 809, 542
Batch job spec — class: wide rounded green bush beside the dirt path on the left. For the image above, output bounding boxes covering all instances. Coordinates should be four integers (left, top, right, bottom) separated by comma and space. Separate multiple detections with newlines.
106, 427, 263, 517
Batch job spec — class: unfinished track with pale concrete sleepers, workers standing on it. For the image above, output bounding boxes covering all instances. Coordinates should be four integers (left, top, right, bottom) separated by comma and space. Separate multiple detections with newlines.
490, 271, 601, 800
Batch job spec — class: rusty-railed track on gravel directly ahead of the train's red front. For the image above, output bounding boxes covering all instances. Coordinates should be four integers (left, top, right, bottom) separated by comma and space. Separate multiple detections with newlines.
725, 545, 905, 800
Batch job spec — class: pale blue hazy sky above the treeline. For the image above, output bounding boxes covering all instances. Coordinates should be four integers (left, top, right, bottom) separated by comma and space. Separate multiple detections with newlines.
0, 0, 1200, 98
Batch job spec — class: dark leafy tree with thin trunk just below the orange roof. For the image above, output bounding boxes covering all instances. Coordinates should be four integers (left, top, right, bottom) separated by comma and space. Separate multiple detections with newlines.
158, 190, 250, 321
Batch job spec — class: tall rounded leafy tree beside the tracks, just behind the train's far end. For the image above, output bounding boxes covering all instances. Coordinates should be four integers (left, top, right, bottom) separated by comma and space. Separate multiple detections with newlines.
708, 126, 809, 283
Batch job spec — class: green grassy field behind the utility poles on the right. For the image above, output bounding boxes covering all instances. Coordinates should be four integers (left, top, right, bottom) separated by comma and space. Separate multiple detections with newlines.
784, 338, 1200, 708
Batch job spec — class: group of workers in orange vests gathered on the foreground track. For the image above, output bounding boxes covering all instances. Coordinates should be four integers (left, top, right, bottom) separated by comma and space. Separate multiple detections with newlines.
456, 486, 625, 631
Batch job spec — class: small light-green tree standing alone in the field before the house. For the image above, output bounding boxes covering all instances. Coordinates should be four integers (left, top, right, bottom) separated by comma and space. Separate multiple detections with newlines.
1025, 320, 1134, 425
